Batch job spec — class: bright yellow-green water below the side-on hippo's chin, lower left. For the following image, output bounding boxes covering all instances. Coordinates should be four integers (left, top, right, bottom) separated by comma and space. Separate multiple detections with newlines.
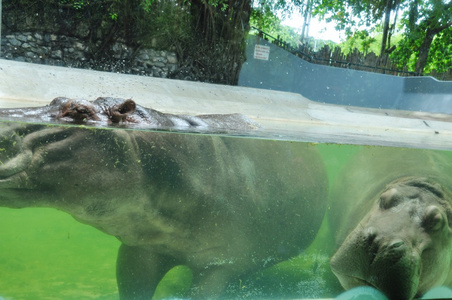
0, 208, 119, 299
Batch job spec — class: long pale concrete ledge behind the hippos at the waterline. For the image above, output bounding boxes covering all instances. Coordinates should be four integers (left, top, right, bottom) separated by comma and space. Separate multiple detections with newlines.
0, 60, 452, 150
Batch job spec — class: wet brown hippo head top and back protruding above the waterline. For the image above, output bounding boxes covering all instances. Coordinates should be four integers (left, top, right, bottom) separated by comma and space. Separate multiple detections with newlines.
0, 97, 259, 132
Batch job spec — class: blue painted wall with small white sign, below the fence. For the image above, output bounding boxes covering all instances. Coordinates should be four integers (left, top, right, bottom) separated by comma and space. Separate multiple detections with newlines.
239, 36, 452, 113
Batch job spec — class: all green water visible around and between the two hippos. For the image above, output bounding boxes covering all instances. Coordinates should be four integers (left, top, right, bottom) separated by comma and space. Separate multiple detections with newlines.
0, 120, 448, 300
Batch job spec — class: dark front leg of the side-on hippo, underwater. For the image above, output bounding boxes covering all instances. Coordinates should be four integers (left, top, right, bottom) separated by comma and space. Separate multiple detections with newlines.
116, 244, 178, 300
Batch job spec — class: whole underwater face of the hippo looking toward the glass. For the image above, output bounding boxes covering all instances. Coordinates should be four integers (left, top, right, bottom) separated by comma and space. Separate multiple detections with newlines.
331, 177, 452, 299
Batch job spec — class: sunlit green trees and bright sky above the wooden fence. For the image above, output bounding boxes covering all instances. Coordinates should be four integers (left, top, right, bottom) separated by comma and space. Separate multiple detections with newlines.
255, 0, 452, 74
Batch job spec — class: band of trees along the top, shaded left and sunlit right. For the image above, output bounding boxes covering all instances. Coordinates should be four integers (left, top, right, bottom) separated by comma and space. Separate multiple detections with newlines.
3, 0, 452, 77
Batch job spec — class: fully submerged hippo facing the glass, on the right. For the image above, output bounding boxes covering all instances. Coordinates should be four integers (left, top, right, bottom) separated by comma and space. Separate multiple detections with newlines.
328, 147, 452, 299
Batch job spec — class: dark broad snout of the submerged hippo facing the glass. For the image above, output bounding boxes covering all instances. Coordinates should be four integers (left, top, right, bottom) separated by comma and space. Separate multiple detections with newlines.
331, 226, 421, 299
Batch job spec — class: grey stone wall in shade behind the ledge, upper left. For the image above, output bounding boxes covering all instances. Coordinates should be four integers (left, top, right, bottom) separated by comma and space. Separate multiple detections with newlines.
0, 32, 178, 78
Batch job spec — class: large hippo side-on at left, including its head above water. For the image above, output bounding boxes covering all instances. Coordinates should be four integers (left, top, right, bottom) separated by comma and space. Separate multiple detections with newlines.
0, 97, 328, 299
